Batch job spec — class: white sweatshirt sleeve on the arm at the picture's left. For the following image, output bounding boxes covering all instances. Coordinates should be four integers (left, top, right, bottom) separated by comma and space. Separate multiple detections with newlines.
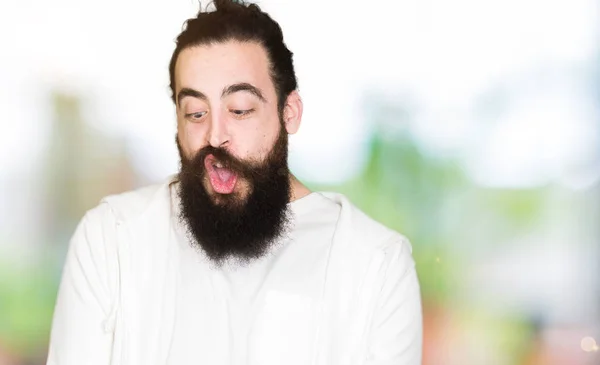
47, 203, 118, 365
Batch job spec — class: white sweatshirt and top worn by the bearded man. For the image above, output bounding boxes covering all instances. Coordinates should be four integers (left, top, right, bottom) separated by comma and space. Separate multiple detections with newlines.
48, 179, 422, 365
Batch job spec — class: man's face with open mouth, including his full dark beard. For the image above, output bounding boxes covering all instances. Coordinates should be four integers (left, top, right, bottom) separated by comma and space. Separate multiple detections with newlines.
175, 42, 290, 263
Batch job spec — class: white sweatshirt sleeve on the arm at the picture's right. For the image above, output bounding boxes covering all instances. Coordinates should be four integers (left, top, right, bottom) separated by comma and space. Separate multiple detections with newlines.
366, 239, 423, 365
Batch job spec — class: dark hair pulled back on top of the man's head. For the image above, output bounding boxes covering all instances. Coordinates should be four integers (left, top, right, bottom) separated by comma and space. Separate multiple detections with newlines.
169, 0, 298, 112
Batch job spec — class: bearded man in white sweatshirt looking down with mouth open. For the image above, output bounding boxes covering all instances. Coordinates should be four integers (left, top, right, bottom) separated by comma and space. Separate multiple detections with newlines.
48, 0, 422, 365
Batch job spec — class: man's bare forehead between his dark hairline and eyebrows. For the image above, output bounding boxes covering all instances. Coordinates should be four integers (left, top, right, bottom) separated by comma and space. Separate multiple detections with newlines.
175, 41, 274, 93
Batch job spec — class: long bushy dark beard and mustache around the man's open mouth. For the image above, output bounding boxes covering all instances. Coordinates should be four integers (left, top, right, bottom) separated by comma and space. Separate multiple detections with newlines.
176, 126, 291, 266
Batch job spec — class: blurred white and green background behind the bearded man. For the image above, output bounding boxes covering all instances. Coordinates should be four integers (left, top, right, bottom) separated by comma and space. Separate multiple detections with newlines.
0, 0, 600, 365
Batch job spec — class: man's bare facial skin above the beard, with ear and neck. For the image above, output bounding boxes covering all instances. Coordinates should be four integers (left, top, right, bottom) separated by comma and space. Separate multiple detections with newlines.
175, 41, 310, 201
